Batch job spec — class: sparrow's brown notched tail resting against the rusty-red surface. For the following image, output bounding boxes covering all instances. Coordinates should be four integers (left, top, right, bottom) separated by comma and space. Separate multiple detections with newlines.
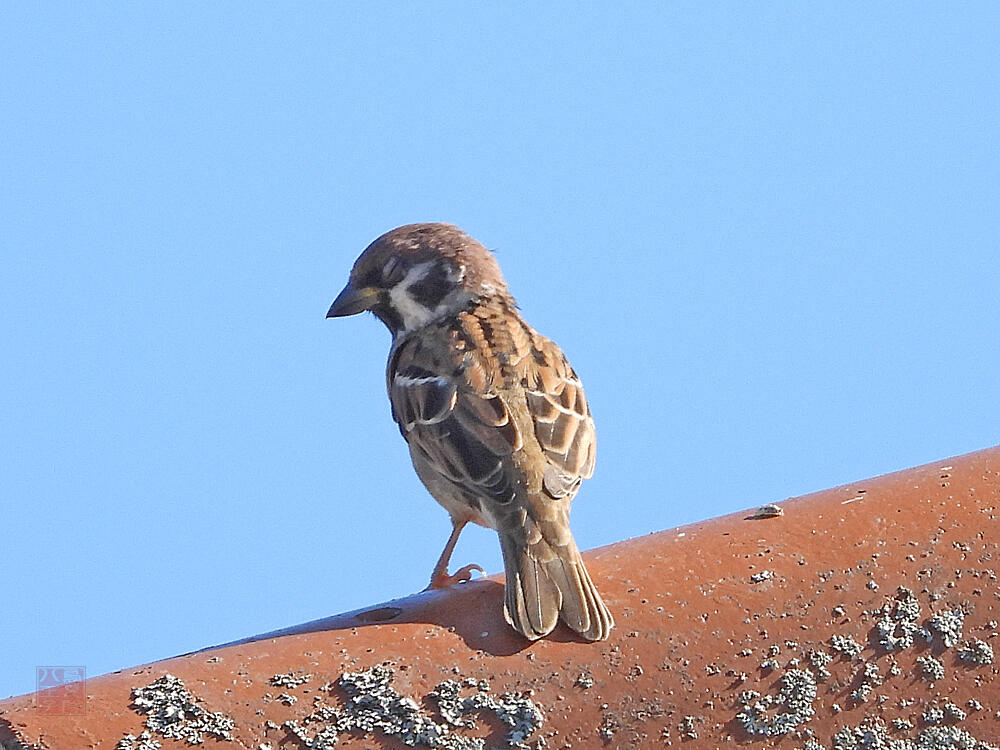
500, 533, 615, 641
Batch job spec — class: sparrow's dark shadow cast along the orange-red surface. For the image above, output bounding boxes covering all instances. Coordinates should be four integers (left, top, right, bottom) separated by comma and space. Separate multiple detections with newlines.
191, 578, 588, 656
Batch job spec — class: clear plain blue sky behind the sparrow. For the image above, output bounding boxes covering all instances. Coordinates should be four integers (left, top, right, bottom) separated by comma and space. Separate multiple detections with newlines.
0, 2, 1000, 696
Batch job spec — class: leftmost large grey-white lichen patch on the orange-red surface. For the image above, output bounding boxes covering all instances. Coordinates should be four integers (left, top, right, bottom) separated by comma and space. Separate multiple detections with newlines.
118, 674, 235, 750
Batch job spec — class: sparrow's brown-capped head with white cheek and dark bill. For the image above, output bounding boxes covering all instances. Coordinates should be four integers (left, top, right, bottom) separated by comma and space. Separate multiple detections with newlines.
326, 224, 513, 336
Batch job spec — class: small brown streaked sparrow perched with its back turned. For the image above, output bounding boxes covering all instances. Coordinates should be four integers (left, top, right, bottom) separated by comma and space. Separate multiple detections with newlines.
327, 224, 614, 641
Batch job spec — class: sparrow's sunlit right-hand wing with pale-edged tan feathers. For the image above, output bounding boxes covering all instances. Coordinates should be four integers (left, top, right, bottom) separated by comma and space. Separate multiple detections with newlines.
524, 336, 597, 498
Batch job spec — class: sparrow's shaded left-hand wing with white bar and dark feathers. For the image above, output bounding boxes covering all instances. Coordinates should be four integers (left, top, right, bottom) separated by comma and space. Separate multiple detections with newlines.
387, 341, 522, 504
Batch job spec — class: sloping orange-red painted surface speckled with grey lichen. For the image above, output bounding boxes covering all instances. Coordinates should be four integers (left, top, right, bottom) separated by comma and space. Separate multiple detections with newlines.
0, 448, 1000, 750
